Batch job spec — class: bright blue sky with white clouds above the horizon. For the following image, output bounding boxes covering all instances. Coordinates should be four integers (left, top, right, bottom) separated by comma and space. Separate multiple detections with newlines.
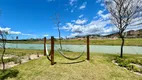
0, 0, 142, 39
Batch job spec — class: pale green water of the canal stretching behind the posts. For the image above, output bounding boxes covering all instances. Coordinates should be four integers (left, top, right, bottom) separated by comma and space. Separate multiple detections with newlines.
6, 43, 142, 54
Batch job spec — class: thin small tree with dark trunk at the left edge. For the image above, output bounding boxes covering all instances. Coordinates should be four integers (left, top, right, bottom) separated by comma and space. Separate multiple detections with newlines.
0, 30, 8, 71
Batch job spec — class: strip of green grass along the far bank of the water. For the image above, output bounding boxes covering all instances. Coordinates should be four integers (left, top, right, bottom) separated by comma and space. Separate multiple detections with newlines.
8, 38, 142, 46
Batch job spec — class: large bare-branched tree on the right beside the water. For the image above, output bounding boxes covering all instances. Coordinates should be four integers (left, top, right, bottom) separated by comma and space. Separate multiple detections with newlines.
105, 0, 142, 58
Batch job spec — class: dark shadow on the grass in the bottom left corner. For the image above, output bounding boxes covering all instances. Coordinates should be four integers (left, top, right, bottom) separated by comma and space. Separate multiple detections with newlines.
0, 69, 19, 80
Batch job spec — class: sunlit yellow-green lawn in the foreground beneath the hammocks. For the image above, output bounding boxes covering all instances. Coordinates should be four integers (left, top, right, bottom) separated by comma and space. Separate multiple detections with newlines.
8, 52, 142, 80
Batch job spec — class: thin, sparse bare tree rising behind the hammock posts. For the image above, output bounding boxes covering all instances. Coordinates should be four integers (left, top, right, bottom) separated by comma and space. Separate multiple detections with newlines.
52, 14, 62, 50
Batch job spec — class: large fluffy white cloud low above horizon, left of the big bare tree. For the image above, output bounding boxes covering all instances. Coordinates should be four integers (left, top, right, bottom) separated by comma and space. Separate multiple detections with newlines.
62, 19, 117, 37
